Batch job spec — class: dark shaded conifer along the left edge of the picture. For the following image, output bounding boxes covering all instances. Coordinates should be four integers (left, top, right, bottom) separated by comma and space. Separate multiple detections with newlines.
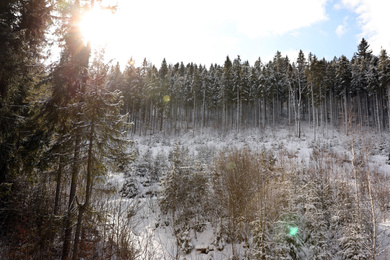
0, 0, 54, 254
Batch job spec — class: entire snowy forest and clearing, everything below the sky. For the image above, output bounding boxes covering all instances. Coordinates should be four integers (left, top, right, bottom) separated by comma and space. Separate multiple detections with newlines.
0, 0, 390, 260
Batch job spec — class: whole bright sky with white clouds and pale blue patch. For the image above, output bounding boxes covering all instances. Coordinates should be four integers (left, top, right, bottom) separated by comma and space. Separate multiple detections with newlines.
87, 0, 390, 68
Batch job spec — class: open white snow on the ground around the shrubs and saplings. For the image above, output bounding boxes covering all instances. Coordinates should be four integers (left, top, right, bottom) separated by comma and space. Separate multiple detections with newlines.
107, 125, 390, 260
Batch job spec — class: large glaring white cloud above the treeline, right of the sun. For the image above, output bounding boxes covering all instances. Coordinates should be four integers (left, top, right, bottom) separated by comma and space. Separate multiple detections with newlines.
97, 0, 328, 65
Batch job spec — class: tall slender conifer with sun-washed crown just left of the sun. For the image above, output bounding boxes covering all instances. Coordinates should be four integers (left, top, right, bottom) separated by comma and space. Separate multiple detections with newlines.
52, 1, 90, 259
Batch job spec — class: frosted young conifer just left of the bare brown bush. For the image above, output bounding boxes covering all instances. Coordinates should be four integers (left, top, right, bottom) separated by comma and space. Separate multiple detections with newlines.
159, 145, 209, 253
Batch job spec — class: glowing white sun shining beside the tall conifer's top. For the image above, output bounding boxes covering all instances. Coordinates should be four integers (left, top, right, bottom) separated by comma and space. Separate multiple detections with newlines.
79, 6, 116, 48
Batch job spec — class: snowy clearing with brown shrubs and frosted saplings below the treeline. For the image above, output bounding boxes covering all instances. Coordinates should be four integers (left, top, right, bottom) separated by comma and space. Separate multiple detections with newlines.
120, 128, 390, 259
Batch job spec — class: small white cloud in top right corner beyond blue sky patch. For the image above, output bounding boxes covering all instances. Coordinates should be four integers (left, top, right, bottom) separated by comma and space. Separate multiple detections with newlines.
342, 0, 390, 54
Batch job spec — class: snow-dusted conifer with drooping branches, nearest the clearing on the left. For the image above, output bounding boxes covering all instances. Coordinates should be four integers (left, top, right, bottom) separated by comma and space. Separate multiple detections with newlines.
73, 49, 133, 259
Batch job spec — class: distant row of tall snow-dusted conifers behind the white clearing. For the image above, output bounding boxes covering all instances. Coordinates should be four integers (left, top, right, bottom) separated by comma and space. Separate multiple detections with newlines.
115, 39, 390, 135
